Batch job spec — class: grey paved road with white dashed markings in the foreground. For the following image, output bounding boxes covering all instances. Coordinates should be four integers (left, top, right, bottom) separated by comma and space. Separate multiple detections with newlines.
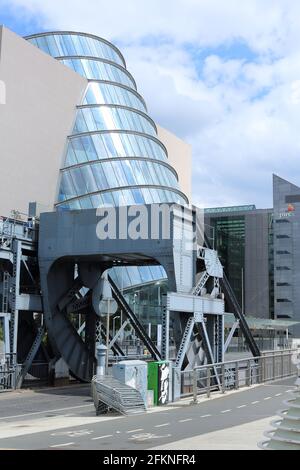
0, 378, 295, 450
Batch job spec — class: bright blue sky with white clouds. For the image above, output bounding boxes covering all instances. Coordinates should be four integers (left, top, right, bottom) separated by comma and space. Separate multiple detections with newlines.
0, 0, 300, 207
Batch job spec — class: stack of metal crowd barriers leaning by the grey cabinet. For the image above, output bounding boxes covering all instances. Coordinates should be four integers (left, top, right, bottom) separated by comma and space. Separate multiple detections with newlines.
92, 376, 146, 415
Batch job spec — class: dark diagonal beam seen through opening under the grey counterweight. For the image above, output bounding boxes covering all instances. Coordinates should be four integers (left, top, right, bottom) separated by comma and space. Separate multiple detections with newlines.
108, 275, 161, 361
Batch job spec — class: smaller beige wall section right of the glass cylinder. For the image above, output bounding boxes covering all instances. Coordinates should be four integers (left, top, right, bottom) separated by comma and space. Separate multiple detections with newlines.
157, 125, 192, 203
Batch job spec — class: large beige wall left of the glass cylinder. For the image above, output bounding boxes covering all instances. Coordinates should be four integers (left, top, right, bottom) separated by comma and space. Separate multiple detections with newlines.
0, 27, 87, 216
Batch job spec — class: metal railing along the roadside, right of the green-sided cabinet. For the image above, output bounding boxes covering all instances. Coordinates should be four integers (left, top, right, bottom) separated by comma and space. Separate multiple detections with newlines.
181, 349, 297, 402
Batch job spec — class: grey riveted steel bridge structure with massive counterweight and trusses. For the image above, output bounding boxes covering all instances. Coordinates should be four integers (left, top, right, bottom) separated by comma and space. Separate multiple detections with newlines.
0, 204, 259, 396
